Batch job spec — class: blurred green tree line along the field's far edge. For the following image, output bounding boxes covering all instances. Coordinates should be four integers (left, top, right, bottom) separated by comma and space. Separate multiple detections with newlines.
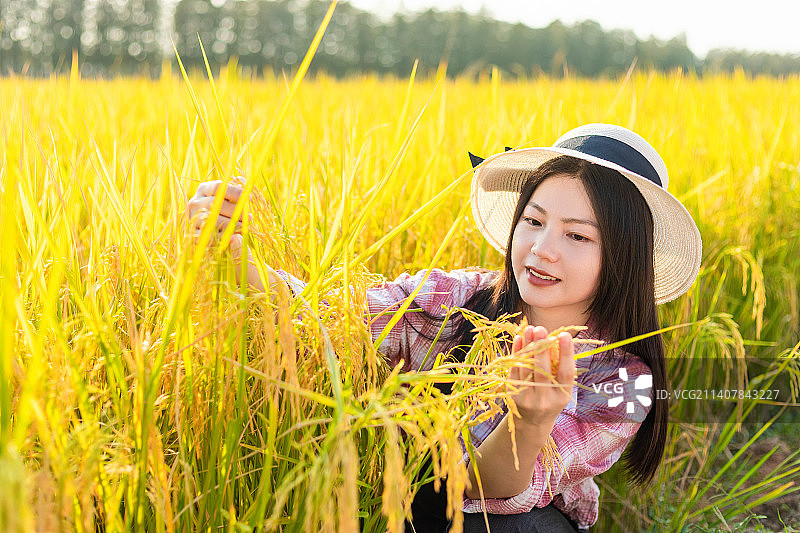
0, 0, 800, 77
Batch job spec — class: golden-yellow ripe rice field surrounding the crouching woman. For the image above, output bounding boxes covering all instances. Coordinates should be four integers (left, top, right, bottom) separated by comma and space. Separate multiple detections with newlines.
0, 38, 800, 532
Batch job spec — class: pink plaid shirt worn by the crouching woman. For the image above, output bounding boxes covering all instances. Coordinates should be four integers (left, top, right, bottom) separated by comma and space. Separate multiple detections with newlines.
367, 269, 653, 527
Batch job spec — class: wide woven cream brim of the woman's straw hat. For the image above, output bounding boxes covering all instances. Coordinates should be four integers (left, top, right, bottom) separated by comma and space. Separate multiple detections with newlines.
472, 147, 703, 304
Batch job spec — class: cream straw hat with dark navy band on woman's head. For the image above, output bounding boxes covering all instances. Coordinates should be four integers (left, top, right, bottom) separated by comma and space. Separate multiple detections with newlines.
470, 124, 702, 304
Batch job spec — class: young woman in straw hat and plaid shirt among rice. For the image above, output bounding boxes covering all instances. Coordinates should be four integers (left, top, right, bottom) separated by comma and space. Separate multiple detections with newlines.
189, 124, 701, 532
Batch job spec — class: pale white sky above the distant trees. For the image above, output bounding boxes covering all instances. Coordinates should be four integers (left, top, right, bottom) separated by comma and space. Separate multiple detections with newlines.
349, 0, 800, 58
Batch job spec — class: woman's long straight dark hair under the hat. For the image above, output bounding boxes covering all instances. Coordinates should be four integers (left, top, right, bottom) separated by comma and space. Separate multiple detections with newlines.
450, 156, 669, 484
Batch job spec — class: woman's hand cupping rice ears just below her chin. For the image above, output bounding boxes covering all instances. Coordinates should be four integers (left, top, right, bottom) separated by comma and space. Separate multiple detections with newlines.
509, 326, 575, 433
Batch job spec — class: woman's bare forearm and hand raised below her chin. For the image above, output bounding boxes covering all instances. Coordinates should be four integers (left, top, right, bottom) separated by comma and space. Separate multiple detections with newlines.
465, 326, 575, 499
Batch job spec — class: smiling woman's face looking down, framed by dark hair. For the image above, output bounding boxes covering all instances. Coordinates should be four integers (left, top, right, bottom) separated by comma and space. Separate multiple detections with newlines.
511, 174, 601, 331
